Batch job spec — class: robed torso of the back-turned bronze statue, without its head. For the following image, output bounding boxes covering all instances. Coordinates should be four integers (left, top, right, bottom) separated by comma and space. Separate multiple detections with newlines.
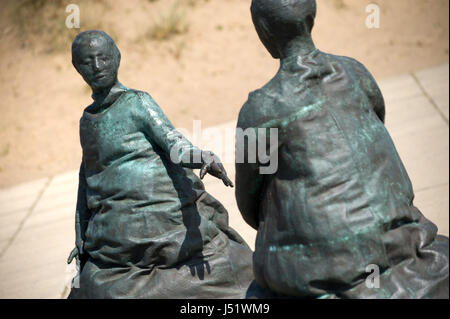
238, 50, 440, 296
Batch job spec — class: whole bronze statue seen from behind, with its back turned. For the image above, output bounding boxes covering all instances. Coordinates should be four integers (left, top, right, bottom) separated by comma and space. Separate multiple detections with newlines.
236, 0, 449, 298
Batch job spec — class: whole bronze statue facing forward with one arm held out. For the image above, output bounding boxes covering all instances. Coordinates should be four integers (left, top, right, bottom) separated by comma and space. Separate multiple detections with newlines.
68, 31, 253, 298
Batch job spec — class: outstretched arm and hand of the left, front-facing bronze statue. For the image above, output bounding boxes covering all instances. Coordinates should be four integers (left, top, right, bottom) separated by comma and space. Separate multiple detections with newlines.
137, 92, 233, 187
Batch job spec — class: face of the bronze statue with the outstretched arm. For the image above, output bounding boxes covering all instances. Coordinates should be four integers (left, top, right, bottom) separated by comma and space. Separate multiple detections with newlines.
73, 36, 119, 92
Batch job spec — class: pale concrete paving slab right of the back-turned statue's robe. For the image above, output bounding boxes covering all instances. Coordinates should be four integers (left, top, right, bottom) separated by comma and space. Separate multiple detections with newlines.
381, 76, 449, 191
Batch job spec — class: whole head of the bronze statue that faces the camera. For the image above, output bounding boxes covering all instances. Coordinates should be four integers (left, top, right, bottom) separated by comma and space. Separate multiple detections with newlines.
72, 30, 120, 93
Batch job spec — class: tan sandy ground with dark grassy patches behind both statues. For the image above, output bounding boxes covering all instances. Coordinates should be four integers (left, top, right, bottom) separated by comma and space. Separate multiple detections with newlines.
0, 0, 449, 188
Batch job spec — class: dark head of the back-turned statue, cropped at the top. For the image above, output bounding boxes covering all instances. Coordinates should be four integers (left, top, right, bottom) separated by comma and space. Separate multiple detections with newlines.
251, 0, 316, 59
